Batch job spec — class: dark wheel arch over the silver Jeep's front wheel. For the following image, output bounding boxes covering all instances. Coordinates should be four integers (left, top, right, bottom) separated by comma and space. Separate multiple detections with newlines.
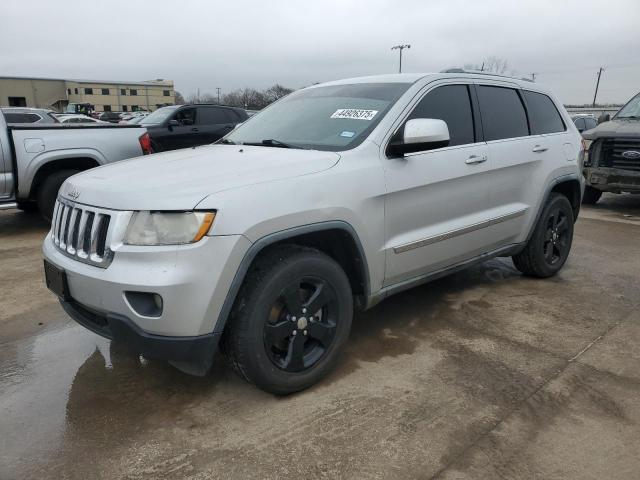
214, 220, 370, 333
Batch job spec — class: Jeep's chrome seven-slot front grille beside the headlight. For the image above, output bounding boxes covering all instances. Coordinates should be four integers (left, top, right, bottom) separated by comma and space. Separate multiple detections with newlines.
51, 199, 116, 268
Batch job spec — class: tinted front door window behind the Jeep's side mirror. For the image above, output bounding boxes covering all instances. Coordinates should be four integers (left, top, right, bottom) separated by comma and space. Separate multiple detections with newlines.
409, 85, 475, 146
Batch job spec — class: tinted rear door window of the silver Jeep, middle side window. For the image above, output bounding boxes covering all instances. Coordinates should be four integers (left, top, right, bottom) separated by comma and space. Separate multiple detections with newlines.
478, 85, 529, 141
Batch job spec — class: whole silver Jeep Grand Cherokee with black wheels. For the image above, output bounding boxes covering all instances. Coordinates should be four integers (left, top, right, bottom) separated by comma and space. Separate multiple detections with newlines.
44, 73, 583, 394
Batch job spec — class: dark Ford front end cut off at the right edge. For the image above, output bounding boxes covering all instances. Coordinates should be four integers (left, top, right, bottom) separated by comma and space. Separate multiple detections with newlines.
583, 93, 640, 204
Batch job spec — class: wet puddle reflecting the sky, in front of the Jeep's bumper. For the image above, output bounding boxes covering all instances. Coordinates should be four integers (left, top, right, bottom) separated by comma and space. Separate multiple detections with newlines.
0, 321, 220, 478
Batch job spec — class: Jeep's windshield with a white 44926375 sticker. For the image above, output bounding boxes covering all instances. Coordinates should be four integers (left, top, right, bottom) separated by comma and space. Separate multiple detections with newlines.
224, 83, 410, 151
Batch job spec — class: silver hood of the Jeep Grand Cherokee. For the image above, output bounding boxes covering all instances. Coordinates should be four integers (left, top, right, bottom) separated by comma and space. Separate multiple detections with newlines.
60, 145, 340, 210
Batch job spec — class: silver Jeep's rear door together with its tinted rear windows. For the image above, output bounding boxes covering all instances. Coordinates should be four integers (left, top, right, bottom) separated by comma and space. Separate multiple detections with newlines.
476, 83, 565, 244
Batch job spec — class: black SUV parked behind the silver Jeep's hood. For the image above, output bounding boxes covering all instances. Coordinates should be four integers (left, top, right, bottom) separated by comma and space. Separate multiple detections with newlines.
140, 105, 249, 152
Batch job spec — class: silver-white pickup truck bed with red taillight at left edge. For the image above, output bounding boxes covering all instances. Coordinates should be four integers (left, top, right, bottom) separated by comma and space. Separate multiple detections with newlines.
0, 113, 151, 219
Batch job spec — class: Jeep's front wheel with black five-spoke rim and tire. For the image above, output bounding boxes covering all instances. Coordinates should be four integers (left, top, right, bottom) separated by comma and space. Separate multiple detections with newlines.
222, 245, 353, 395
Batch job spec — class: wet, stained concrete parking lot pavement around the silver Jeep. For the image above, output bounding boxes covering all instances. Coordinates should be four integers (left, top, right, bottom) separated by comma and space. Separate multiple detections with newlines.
0, 196, 640, 479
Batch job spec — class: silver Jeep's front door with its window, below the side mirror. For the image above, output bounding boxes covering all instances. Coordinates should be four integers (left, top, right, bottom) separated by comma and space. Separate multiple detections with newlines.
384, 83, 491, 285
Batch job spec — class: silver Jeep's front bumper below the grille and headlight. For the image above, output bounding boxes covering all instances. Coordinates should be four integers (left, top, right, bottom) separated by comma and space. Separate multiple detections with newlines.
43, 234, 250, 340
